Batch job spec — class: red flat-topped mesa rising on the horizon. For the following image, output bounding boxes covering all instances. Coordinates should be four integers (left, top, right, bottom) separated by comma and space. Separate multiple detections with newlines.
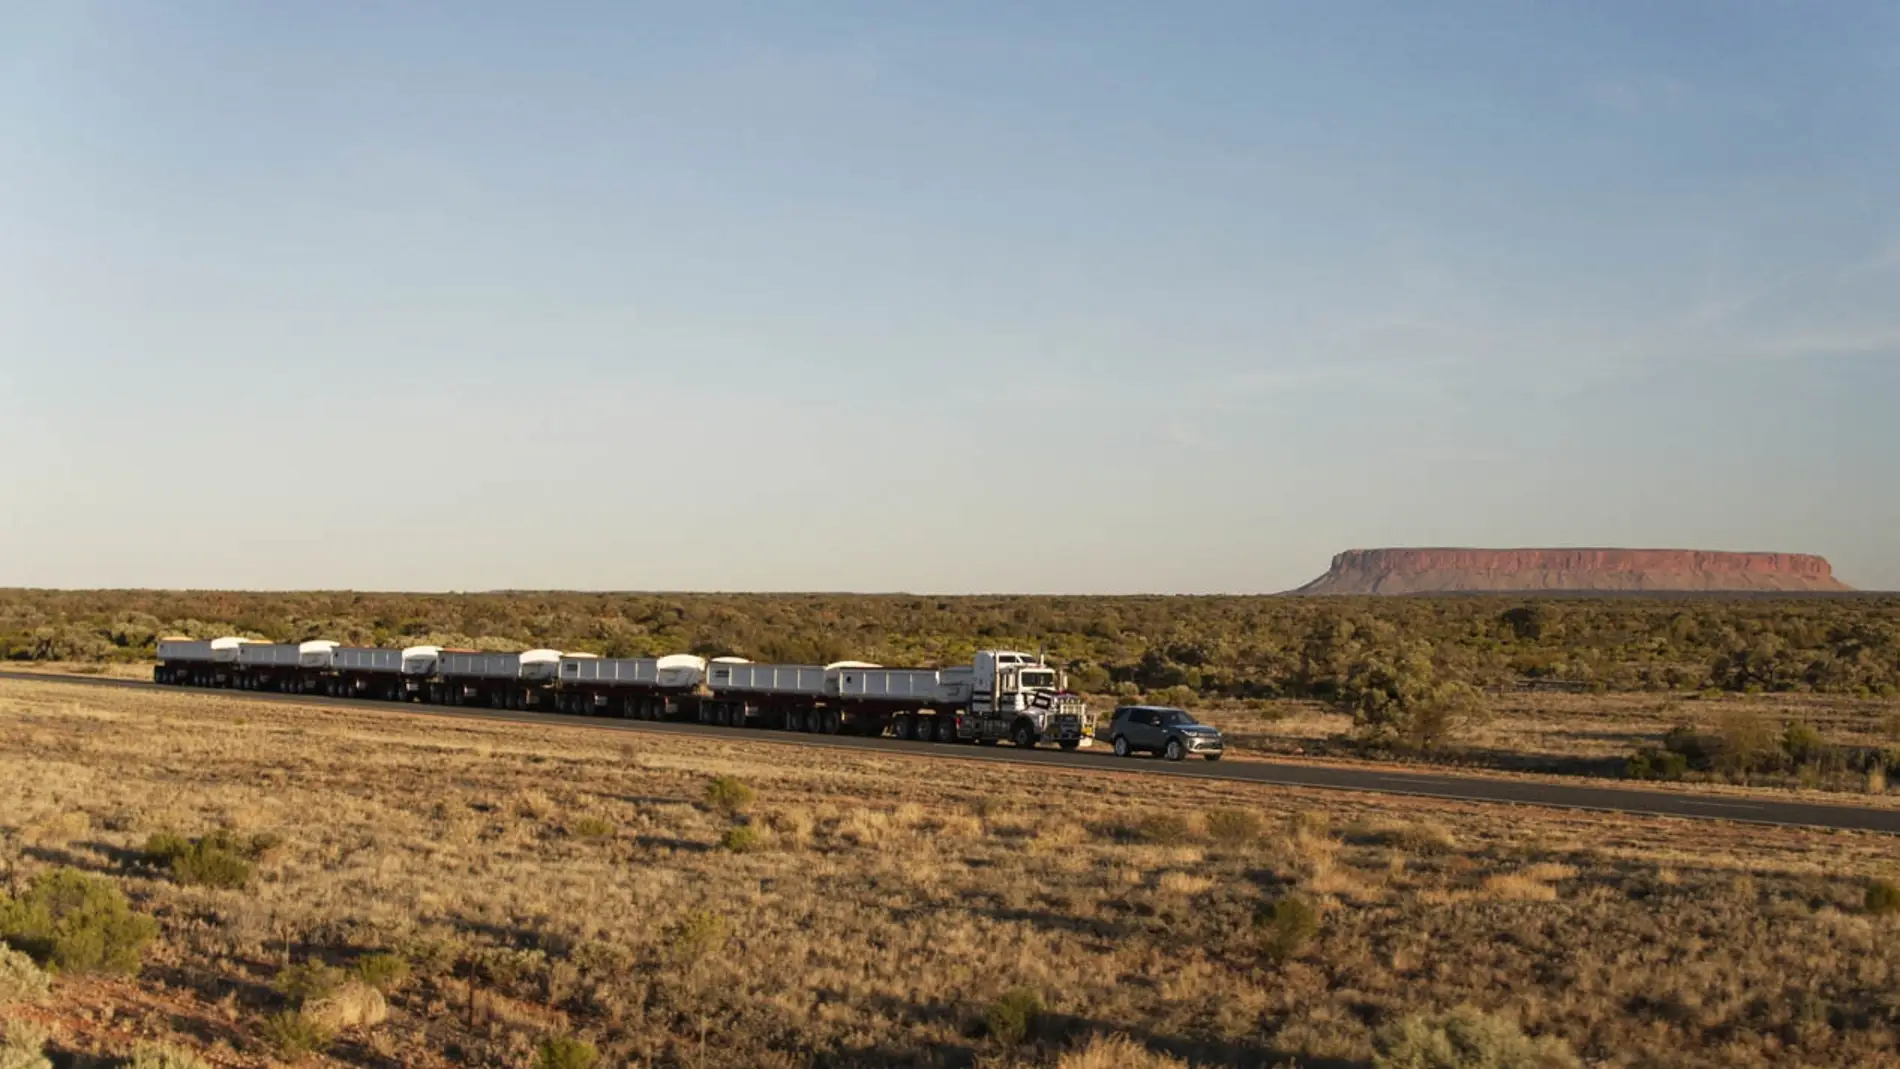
1292, 549, 1853, 594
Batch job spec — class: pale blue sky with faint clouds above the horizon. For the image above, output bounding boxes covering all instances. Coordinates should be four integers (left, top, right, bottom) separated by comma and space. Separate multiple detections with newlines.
0, 0, 1900, 592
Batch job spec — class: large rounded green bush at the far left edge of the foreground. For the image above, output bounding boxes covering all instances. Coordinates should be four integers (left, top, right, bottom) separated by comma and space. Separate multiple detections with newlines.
0, 868, 158, 974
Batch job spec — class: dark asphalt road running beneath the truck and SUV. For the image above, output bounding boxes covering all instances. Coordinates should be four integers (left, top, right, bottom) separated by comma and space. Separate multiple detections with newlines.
14, 672, 1900, 834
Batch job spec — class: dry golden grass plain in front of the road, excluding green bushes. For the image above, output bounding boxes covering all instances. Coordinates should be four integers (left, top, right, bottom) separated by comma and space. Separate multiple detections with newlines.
0, 682, 1900, 1069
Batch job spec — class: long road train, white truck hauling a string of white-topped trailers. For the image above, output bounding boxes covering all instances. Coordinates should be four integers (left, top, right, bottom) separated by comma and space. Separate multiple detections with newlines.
152, 638, 1094, 750
